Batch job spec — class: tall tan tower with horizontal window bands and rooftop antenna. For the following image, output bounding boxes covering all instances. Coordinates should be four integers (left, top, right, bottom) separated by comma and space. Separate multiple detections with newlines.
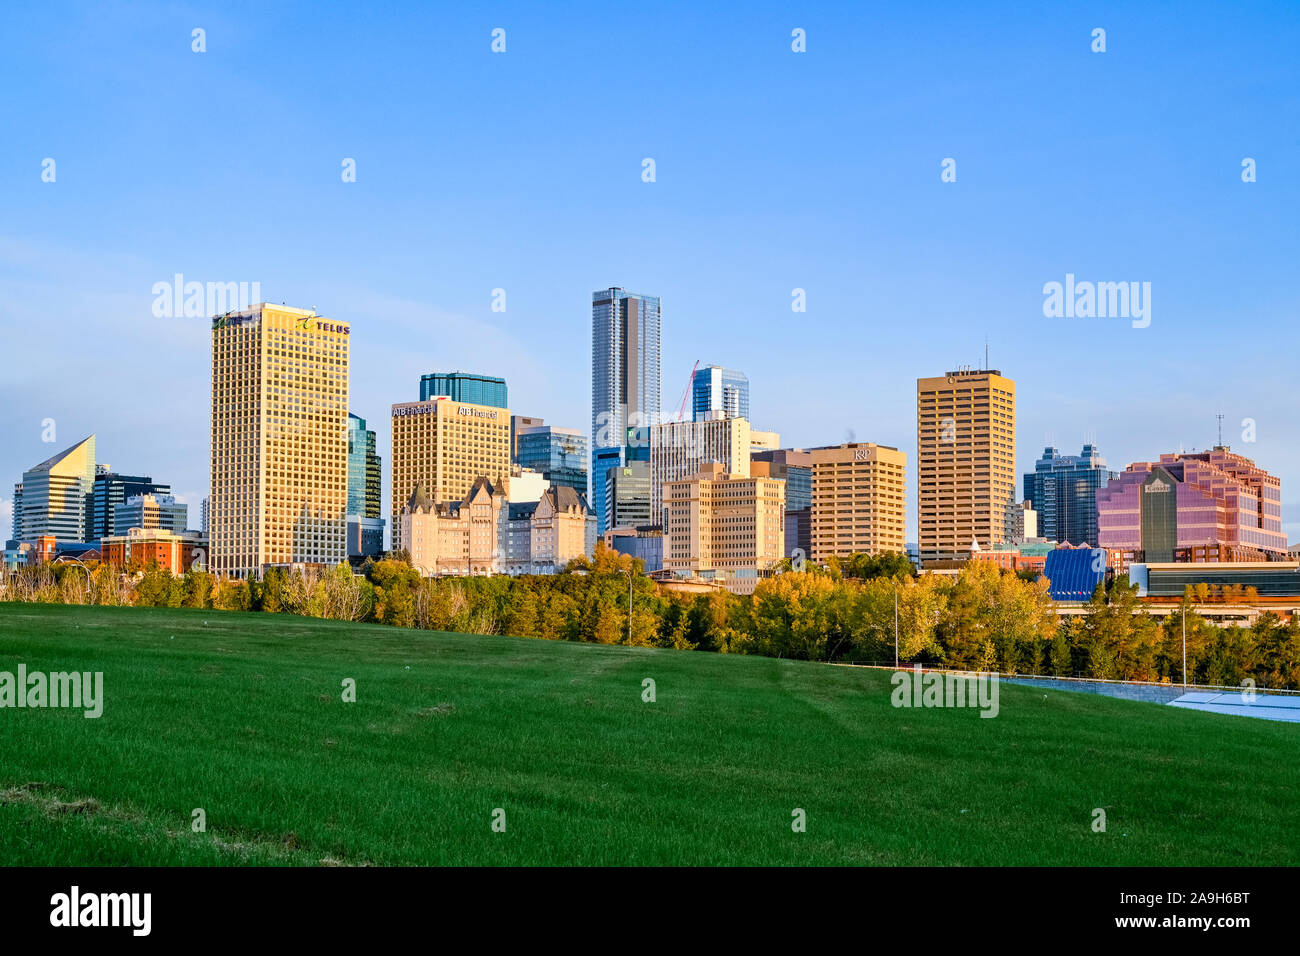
917, 368, 1015, 562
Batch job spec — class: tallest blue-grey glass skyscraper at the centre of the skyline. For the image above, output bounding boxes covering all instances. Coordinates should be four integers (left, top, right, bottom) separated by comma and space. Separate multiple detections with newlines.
592, 287, 660, 535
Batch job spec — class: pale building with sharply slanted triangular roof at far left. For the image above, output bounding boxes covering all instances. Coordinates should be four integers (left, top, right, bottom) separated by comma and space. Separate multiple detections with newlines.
14, 434, 95, 544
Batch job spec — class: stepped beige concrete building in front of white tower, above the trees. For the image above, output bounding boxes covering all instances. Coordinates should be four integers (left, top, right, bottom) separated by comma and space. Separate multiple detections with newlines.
663, 463, 785, 593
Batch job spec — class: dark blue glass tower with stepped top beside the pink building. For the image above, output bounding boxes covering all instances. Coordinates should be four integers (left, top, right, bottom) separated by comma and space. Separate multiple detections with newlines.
1024, 444, 1115, 545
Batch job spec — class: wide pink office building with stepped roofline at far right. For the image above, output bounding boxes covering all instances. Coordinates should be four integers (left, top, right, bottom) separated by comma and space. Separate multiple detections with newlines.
1097, 446, 1287, 564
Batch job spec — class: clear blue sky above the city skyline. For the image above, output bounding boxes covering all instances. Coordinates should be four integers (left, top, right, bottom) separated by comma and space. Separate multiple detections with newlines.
0, 3, 1300, 538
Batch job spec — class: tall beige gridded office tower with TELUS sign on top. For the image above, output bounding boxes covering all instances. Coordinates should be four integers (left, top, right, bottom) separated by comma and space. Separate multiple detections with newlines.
208, 303, 350, 578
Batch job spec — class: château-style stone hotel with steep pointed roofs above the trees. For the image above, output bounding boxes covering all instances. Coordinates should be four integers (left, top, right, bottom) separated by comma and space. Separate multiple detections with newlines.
397, 476, 588, 576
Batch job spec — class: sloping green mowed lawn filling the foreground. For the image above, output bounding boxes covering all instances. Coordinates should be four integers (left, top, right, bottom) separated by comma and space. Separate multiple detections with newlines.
0, 604, 1300, 865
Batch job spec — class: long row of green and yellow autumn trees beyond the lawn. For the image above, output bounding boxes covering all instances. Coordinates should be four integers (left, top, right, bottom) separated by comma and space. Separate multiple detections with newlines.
5, 546, 1300, 688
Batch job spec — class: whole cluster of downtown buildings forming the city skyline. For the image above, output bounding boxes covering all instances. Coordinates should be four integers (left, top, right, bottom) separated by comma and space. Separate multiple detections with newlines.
5, 287, 1288, 600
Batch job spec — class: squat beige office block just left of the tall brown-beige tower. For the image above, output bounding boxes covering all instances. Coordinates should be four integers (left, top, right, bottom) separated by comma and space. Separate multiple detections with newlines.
809, 442, 907, 563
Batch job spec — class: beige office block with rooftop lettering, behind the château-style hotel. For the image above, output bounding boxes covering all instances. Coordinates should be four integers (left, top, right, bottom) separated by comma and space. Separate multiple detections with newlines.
389, 397, 510, 548
